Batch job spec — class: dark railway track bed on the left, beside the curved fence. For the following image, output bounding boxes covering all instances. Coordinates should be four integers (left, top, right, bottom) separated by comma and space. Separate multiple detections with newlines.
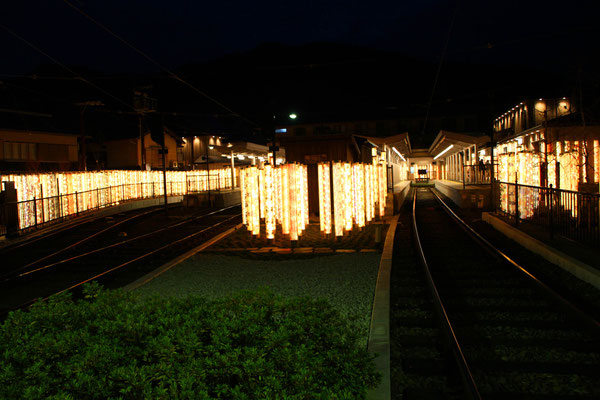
0, 206, 241, 315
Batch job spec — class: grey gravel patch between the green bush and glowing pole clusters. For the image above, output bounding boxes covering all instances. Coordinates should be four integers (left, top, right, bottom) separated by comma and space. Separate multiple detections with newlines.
137, 253, 381, 346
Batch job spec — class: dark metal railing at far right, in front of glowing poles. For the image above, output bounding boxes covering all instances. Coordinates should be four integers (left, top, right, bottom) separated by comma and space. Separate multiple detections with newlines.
494, 182, 600, 246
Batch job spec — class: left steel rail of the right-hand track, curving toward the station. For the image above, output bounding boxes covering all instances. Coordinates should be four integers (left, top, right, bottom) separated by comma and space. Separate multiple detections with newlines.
412, 190, 481, 400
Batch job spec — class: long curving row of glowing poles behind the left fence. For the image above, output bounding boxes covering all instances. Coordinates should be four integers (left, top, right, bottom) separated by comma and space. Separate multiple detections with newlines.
0, 168, 236, 229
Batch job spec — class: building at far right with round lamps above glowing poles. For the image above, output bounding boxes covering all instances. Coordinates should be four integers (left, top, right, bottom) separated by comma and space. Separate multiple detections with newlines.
494, 97, 600, 193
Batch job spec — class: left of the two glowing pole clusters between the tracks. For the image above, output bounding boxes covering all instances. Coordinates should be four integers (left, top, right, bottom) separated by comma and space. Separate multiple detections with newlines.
240, 164, 308, 240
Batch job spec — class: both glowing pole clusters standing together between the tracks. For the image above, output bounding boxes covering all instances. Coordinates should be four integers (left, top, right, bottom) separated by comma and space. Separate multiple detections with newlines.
240, 153, 387, 240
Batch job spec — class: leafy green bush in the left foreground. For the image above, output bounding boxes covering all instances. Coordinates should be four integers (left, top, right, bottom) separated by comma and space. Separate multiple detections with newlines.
0, 285, 379, 399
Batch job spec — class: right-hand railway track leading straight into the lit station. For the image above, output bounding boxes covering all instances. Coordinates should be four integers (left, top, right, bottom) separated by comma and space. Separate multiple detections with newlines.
392, 189, 600, 399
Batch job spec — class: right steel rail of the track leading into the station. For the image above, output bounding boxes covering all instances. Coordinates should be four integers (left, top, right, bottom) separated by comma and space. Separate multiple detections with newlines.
429, 189, 600, 337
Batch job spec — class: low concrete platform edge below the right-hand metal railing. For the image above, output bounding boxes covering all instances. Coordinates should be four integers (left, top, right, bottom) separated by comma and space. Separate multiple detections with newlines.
481, 212, 600, 289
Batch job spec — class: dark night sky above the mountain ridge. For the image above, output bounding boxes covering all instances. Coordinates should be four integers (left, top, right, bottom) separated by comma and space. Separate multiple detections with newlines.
0, 0, 600, 74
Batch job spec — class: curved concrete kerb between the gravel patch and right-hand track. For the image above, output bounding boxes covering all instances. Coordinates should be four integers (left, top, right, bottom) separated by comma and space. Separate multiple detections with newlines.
367, 215, 399, 400
